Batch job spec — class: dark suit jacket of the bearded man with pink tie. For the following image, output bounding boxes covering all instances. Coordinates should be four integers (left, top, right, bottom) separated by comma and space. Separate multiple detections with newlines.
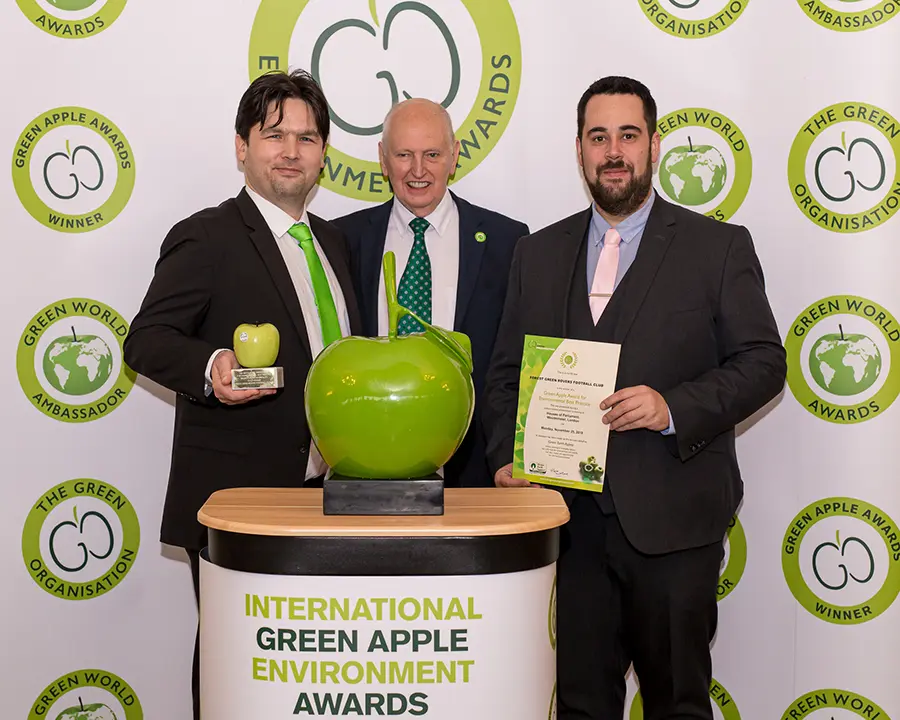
485, 197, 787, 554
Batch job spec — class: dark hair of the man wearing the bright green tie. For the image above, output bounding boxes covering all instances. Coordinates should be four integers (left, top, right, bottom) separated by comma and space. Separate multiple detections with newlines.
234, 70, 331, 143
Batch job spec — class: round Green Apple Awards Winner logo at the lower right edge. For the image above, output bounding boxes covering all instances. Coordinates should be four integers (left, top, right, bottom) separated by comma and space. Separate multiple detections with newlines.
781, 497, 900, 625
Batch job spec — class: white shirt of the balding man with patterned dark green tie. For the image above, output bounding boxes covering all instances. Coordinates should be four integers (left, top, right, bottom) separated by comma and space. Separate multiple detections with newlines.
378, 190, 459, 335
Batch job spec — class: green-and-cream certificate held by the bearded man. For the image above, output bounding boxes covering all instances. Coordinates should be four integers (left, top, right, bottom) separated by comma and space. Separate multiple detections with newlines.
513, 335, 621, 492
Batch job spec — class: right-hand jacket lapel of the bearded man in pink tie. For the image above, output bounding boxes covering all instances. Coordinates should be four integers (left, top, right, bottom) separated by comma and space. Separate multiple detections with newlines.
601, 195, 675, 343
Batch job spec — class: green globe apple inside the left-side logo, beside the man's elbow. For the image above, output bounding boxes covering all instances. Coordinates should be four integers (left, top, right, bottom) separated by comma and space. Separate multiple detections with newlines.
43, 327, 113, 395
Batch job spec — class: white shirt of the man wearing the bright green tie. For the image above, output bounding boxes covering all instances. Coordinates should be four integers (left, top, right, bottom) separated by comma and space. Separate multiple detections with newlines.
206, 186, 350, 479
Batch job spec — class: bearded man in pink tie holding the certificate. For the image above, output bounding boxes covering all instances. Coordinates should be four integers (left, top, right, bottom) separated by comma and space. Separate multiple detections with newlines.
485, 77, 786, 720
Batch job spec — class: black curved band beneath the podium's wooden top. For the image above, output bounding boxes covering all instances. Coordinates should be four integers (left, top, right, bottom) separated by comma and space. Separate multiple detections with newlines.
209, 528, 559, 576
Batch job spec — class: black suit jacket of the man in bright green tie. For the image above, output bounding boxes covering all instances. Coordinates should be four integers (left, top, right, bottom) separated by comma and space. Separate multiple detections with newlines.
125, 190, 360, 549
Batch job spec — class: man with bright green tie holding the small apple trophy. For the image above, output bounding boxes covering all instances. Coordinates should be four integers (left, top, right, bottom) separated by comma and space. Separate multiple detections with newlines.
125, 71, 360, 718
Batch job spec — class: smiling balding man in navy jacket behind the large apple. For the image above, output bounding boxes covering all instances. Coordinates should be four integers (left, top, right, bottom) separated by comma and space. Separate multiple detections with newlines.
333, 98, 528, 487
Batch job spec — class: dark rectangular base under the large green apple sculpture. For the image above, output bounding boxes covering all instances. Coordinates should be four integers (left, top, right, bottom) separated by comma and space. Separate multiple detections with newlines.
322, 473, 444, 515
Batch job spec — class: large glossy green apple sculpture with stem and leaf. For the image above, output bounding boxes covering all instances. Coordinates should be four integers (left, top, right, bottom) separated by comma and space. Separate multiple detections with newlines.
305, 252, 475, 479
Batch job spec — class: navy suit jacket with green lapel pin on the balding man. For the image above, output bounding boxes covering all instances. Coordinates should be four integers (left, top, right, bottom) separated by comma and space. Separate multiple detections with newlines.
332, 193, 528, 487
